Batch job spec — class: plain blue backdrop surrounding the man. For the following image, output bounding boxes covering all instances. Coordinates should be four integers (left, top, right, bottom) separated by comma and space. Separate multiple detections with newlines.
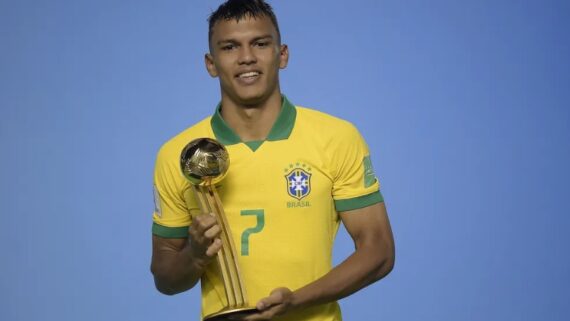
0, 0, 570, 321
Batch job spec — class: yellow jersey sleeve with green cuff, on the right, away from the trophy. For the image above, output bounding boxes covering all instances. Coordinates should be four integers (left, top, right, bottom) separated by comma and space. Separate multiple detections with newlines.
329, 124, 384, 212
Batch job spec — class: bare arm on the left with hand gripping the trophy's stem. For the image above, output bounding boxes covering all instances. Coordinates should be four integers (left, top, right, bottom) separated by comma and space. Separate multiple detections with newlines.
150, 214, 222, 295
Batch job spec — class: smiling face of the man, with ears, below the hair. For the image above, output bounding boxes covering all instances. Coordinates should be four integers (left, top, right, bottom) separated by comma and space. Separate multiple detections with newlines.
206, 17, 289, 106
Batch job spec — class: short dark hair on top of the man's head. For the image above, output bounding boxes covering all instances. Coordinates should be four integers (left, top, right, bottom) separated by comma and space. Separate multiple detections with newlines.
208, 0, 281, 43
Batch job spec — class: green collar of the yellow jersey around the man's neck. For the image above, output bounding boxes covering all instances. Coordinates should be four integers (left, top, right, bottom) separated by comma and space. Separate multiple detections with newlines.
211, 95, 297, 151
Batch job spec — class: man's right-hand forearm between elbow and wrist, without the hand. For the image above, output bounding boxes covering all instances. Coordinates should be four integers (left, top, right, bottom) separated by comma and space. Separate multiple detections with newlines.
293, 241, 394, 308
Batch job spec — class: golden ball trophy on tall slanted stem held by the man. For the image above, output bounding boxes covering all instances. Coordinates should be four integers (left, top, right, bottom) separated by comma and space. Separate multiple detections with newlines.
180, 138, 257, 321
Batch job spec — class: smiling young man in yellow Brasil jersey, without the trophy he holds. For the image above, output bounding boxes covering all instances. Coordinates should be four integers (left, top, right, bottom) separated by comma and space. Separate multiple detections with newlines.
151, 0, 394, 321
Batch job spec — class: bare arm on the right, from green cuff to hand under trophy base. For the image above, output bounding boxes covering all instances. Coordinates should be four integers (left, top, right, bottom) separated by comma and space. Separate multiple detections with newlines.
246, 203, 395, 320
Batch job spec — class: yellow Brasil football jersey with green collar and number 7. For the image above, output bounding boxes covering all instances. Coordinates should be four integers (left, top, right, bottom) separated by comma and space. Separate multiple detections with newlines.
152, 97, 383, 321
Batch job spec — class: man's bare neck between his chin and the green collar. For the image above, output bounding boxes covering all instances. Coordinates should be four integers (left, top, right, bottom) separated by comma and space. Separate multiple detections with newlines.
221, 90, 281, 142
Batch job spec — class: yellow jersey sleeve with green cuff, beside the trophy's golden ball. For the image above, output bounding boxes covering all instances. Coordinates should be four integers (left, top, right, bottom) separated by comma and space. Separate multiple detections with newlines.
152, 146, 191, 238
